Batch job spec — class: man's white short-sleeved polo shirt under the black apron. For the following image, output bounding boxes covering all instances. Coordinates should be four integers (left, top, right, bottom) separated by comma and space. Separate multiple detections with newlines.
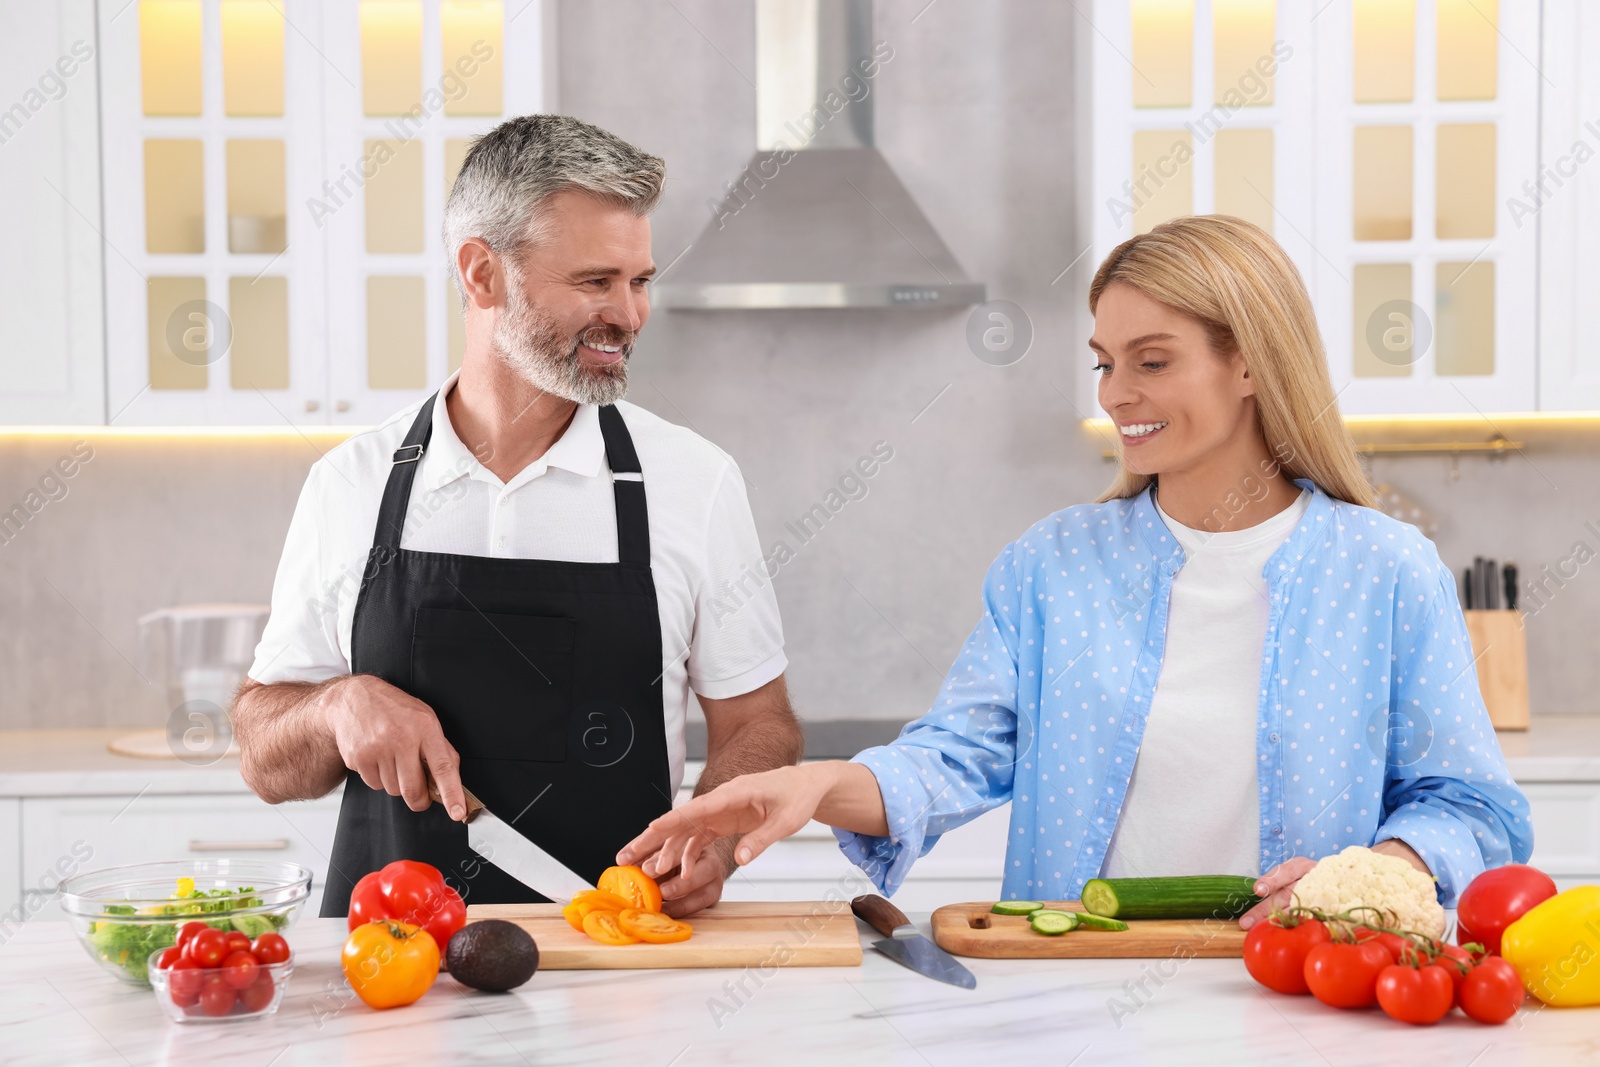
250, 374, 789, 792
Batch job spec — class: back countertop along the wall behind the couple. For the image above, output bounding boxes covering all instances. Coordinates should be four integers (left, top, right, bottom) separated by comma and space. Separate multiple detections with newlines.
0, 715, 1600, 797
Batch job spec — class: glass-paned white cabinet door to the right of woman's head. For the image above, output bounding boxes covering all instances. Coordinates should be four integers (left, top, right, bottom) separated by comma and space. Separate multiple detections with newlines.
1312, 0, 1536, 416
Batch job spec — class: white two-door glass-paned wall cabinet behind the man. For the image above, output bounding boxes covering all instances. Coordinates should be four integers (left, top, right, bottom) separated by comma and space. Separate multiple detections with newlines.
84, 0, 547, 427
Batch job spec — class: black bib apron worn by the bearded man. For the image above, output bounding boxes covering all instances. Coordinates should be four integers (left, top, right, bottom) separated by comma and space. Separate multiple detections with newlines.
322, 394, 672, 918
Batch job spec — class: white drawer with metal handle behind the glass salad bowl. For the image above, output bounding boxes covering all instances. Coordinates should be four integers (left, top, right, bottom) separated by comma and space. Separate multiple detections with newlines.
21, 790, 342, 918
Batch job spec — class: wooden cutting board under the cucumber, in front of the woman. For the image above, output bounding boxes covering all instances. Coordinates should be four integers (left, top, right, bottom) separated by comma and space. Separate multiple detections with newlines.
933, 901, 1245, 960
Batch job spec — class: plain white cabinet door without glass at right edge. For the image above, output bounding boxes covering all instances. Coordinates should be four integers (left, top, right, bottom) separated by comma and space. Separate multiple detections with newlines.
1517, 0, 1600, 411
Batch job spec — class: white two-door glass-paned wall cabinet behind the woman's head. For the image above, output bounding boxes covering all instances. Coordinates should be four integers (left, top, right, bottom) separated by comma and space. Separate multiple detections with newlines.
1074, 0, 1542, 416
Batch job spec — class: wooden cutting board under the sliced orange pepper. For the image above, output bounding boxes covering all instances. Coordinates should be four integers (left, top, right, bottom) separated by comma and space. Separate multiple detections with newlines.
467, 901, 864, 971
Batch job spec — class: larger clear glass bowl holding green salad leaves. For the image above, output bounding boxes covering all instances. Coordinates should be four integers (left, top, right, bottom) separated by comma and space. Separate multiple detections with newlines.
61, 859, 312, 985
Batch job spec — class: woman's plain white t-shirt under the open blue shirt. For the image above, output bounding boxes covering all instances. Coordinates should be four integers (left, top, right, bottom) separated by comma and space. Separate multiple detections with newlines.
1101, 490, 1310, 878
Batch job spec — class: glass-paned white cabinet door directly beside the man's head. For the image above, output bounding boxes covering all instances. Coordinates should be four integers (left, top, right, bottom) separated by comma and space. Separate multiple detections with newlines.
315, 0, 544, 426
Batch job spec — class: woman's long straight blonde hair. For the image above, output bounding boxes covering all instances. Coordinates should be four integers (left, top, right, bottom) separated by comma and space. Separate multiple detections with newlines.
1090, 214, 1376, 507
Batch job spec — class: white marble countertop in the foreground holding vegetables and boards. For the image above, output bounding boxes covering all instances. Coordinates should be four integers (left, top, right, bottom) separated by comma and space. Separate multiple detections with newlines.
0, 915, 1600, 1067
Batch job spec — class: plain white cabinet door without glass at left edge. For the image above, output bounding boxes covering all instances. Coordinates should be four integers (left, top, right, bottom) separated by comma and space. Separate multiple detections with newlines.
0, 0, 106, 424
